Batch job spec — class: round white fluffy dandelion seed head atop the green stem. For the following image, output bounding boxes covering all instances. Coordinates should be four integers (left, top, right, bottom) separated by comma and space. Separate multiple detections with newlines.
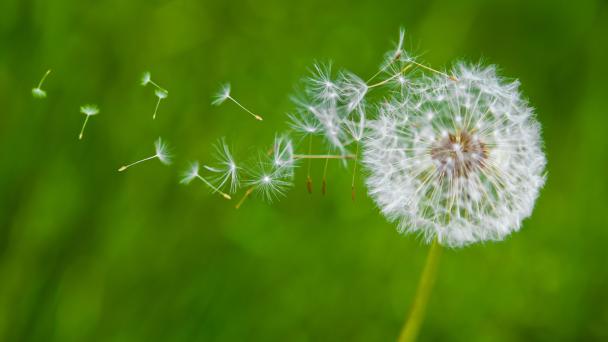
364, 64, 546, 247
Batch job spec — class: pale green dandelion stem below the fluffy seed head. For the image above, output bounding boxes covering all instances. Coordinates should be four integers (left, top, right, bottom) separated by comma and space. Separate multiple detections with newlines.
398, 238, 441, 342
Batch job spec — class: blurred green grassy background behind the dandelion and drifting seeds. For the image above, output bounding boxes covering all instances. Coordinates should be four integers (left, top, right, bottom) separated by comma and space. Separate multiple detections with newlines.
0, 0, 608, 341
